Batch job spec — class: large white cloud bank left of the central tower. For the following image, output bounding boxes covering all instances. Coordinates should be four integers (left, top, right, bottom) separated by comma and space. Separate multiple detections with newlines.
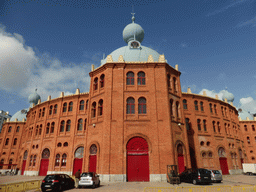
0, 26, 90, 101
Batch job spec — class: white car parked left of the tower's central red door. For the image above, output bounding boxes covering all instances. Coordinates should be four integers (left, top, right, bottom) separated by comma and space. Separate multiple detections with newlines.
78, 172, 100, 188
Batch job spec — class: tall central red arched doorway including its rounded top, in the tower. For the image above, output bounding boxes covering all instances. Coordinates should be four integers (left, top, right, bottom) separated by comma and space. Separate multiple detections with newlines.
126, 137, 149, 181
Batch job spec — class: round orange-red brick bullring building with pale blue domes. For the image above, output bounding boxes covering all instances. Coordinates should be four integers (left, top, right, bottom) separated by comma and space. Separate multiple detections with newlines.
0, 17, 253, 182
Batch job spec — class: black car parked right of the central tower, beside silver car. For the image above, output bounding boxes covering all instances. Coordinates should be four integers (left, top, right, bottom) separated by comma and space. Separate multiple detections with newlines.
179, 169, 212, 185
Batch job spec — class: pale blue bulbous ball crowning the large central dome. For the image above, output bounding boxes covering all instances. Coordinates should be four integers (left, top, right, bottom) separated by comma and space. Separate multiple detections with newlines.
123, 23, 144, 43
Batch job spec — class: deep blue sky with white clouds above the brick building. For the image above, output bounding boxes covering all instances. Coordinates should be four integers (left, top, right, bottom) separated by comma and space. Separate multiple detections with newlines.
0, 0, 256, 115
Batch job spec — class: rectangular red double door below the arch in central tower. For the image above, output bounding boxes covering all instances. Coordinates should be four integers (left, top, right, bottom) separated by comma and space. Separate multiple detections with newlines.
127, 154, 149, 181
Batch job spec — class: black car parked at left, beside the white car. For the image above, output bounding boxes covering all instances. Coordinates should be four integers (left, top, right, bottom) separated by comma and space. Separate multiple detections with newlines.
41, 174, 75, 192
